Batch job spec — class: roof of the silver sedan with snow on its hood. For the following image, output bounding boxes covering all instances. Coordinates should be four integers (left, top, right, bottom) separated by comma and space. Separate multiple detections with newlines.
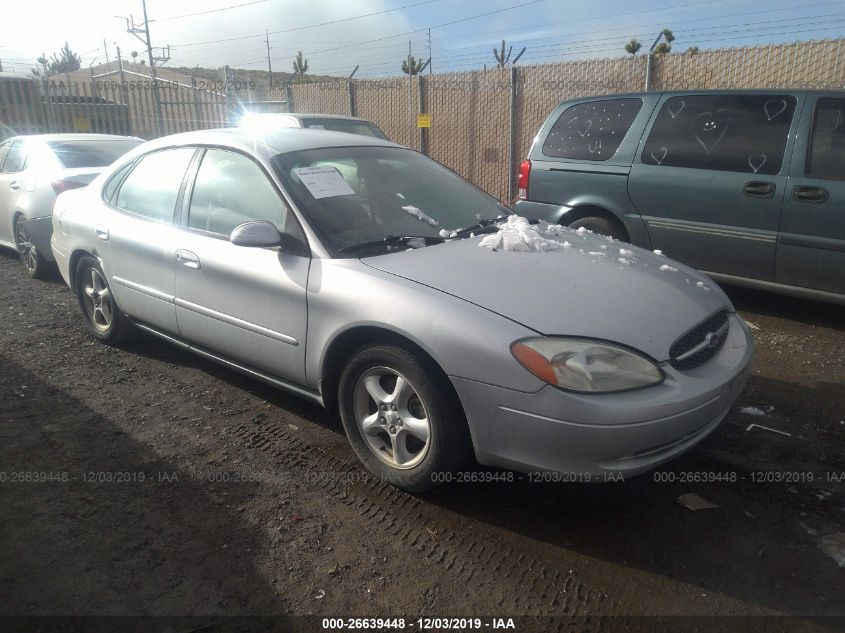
127, 127, 402, 158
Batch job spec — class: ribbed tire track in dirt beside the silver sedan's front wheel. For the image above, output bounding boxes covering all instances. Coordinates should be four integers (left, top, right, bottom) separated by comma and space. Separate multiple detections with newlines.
234, 420, 654, 631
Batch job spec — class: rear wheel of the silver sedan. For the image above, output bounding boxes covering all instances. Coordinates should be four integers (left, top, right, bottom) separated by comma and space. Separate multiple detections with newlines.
76, 257, 132, 345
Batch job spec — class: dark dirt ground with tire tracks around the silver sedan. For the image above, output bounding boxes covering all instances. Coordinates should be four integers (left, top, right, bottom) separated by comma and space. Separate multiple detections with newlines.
0, 252, 845, 630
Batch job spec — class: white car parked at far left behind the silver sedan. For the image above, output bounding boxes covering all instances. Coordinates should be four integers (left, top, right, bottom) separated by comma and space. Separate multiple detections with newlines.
0, 134, 144, 277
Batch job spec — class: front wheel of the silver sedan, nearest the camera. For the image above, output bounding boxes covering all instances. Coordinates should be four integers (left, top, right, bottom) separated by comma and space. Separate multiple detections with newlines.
338, 345, 471, 492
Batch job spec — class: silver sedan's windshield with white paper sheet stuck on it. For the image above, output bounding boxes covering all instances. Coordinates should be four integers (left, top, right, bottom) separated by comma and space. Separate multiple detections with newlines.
273, 147, 509, 254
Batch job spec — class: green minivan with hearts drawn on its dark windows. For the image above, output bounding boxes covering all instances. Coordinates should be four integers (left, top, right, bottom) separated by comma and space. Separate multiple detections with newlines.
516, 90, 845, 304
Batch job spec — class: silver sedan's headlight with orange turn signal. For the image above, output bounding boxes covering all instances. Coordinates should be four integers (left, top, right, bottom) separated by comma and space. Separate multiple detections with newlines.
511, 337, 664, 393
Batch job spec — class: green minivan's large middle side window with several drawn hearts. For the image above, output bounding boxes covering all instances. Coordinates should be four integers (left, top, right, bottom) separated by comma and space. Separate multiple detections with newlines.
642, 94, 796, 175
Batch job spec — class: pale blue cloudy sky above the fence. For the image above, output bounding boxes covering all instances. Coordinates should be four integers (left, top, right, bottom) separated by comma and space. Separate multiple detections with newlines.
0, 0, 845, 78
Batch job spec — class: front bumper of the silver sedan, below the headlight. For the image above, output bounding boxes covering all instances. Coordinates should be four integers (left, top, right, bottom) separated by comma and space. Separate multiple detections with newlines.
452, 315, 753, 477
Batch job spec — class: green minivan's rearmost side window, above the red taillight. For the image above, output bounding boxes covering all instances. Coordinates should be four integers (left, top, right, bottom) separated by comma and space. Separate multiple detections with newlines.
543, 98, 643, 161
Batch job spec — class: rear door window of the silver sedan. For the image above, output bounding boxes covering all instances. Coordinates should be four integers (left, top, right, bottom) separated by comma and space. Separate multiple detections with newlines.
115, 147, 195, 222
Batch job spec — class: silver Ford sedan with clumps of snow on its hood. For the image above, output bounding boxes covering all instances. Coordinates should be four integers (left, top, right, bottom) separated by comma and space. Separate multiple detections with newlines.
52, 129, 752, 490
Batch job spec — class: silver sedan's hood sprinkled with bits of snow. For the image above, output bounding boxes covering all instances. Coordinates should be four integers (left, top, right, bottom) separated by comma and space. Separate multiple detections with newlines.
362, 229, 733, 361
